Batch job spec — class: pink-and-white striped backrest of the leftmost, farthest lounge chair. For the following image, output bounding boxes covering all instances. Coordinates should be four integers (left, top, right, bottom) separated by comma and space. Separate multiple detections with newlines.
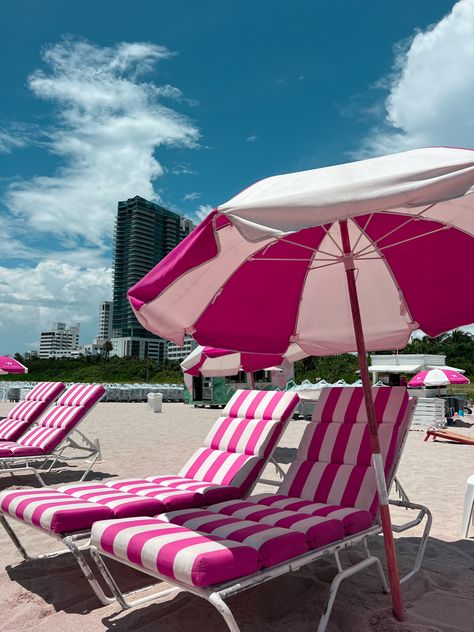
0, 382, 66, 441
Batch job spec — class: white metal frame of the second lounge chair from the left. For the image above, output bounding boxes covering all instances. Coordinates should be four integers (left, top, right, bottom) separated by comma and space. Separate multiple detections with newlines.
0, 397, 102, 487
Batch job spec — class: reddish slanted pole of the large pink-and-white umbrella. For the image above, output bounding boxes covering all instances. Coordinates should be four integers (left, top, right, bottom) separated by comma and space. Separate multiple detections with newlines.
339, 220, 405, 621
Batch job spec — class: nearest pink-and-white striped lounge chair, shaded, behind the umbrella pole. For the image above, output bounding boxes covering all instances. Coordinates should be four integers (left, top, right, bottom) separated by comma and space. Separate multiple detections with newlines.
91, 388, 434, 632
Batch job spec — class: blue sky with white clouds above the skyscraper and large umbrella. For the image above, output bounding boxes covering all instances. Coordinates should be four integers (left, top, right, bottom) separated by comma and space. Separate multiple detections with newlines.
0, 0, 474, 353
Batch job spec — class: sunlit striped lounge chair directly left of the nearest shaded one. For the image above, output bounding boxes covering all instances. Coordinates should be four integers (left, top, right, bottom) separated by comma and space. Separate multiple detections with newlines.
0, 390, 299, 603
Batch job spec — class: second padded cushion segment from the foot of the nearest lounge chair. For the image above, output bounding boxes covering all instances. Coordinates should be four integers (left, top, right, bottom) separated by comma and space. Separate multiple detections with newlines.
159, 508, 308, 568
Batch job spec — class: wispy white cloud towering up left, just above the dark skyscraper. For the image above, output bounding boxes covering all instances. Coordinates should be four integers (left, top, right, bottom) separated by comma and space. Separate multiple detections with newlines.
7, 39, 199, 245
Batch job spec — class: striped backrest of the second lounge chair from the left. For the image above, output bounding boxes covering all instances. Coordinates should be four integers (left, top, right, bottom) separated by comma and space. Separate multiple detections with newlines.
13, 384, 105, 452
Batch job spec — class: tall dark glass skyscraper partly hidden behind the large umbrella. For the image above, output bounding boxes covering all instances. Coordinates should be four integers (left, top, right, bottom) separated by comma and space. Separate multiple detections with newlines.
113, 196, 189, 344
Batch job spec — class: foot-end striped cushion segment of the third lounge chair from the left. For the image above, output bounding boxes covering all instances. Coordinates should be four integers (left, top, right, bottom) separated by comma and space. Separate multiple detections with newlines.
0, 487, 113, 533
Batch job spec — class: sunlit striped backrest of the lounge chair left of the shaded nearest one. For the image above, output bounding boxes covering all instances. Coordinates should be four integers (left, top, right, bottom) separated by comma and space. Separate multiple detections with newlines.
179, 390, 299, 494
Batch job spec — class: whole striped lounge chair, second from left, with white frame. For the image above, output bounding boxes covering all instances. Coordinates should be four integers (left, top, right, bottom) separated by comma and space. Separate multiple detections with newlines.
0, 384, 105, 485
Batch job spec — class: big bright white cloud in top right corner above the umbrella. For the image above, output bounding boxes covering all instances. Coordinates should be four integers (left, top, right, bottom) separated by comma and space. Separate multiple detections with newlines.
358, 0, 474, 157
